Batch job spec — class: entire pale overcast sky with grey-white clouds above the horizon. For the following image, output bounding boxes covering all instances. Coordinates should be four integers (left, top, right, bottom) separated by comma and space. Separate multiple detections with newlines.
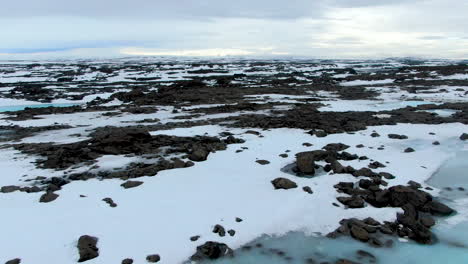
0, 0, 468, 59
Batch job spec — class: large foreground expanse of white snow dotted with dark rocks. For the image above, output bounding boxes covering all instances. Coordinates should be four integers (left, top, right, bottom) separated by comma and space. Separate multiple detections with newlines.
0, 124, 466, 264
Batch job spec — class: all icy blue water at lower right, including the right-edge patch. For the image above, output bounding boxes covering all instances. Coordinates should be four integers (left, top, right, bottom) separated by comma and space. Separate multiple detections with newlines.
213, 151, 468, 264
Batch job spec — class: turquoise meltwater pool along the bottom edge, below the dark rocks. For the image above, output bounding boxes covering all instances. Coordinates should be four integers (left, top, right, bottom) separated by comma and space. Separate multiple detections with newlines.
210, 232, 468, 264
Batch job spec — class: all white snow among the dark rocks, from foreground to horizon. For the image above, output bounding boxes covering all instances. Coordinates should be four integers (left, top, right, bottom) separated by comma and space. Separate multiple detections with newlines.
0, 61, 468, 264
